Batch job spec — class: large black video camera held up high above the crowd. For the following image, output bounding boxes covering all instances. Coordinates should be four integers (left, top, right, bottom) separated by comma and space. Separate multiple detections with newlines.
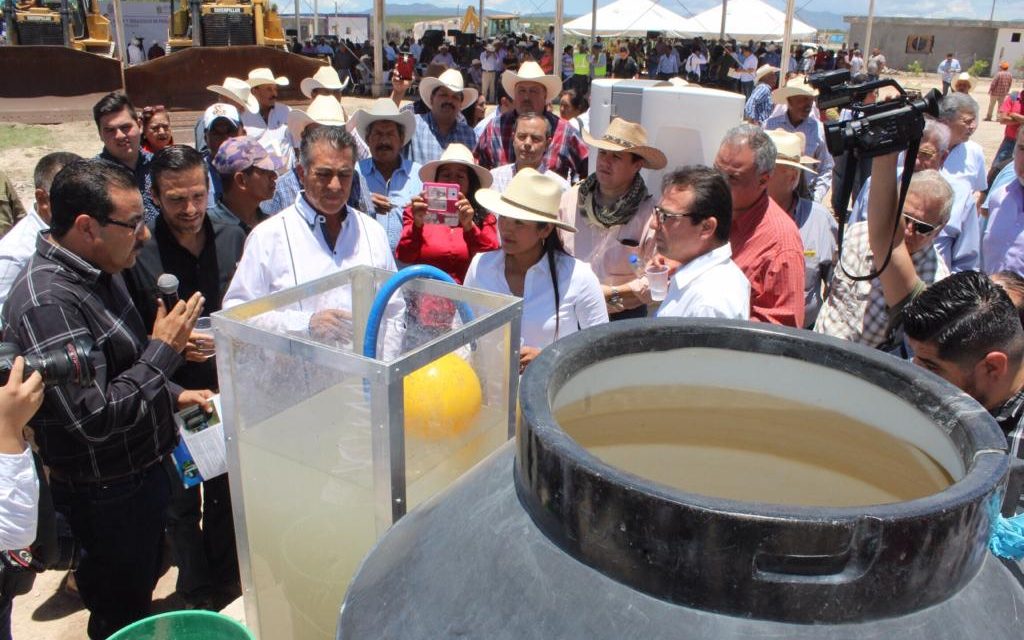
807, 69, 941, 158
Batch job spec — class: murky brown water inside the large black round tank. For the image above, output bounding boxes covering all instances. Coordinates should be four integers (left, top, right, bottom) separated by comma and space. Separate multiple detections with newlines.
555, 385, 952, 507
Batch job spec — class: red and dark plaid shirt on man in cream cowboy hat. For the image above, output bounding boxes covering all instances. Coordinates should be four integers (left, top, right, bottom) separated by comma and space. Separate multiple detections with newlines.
473, 110, 590, 183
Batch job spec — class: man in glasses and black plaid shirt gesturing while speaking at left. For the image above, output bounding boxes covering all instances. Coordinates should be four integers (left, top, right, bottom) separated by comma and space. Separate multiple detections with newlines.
3, 160, 209, 638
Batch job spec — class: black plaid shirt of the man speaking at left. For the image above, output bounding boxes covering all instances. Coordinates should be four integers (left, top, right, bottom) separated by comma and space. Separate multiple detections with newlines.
3, 233, 183, 482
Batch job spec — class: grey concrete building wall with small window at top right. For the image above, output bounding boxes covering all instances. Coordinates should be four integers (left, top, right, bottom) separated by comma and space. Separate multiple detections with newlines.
847, 17, 995, 72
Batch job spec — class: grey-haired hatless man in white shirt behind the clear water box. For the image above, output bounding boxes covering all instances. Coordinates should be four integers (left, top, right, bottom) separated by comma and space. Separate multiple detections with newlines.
223, 126, 400, 343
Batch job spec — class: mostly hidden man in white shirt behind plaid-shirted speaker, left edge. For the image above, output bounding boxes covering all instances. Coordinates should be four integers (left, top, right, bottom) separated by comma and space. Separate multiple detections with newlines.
0, 152, 81, 307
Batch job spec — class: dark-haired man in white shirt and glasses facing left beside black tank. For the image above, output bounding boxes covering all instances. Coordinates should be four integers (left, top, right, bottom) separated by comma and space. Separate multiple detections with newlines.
651, 165, 751, 319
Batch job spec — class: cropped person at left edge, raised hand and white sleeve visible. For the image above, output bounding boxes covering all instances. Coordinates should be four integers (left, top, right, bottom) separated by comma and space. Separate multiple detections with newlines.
0, 356, 43, 639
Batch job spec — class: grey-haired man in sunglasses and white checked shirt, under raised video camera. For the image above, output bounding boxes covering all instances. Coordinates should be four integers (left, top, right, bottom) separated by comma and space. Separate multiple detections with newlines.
814, 154, 953, 350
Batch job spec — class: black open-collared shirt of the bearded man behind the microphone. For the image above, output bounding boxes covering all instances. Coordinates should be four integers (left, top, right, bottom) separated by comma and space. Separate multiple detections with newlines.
125, 216, 246, 389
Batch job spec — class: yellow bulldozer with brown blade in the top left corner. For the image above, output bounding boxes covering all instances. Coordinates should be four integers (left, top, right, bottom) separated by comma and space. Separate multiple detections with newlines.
0, 0, 123, 98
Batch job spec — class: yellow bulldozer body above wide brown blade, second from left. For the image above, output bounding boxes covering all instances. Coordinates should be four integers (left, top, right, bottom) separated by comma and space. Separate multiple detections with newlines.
167, 0, 287, 53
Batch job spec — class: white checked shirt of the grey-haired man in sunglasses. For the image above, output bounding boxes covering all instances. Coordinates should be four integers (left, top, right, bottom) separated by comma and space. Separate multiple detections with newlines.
814, 221, 949, 347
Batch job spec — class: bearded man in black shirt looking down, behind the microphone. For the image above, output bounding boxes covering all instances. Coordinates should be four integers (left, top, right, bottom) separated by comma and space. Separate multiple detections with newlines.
126, 144, 245, 610
